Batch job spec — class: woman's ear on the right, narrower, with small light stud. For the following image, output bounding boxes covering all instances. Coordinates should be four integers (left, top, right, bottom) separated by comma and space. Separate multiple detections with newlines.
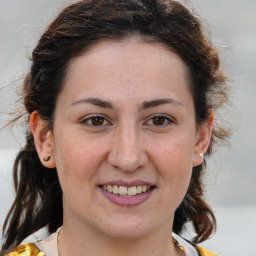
193, 110, 214, 167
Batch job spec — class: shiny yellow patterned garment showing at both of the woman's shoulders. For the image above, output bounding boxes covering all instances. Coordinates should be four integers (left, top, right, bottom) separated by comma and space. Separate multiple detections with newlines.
4, 243, 218, 256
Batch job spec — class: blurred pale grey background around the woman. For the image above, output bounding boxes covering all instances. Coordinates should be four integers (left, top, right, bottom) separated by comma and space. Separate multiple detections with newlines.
0, 0, 256, 256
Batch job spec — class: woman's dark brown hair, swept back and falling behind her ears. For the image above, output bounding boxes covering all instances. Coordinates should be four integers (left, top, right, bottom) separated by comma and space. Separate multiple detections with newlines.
2, 0, 228, 250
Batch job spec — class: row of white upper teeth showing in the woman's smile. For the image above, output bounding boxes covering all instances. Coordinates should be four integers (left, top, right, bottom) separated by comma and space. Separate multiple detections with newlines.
101, 185, 155, 197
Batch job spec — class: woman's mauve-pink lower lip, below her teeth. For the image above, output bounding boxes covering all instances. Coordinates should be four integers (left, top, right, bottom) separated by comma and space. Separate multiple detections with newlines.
100, 188, 154, 206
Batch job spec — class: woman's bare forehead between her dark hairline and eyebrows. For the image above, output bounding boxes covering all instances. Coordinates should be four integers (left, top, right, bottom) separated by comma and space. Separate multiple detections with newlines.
60, 38, 192, 105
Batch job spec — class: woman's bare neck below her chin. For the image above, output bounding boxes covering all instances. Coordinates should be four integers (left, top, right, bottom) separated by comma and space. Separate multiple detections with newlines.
59, 224, 178, 256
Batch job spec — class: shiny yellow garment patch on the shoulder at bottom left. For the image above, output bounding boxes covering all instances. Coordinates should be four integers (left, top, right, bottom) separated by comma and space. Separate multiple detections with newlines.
4, 243, 45, 256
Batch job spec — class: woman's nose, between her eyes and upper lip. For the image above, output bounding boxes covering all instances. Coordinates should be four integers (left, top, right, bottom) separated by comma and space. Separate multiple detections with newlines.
108, 125, 148, 172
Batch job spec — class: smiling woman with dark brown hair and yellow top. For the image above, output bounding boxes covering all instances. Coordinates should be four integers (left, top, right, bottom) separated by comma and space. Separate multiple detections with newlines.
2, 0, 228, 256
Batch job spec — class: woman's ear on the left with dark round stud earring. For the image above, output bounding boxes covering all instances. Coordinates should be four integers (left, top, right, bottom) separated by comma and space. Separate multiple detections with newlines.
30, 111, 56, 168
